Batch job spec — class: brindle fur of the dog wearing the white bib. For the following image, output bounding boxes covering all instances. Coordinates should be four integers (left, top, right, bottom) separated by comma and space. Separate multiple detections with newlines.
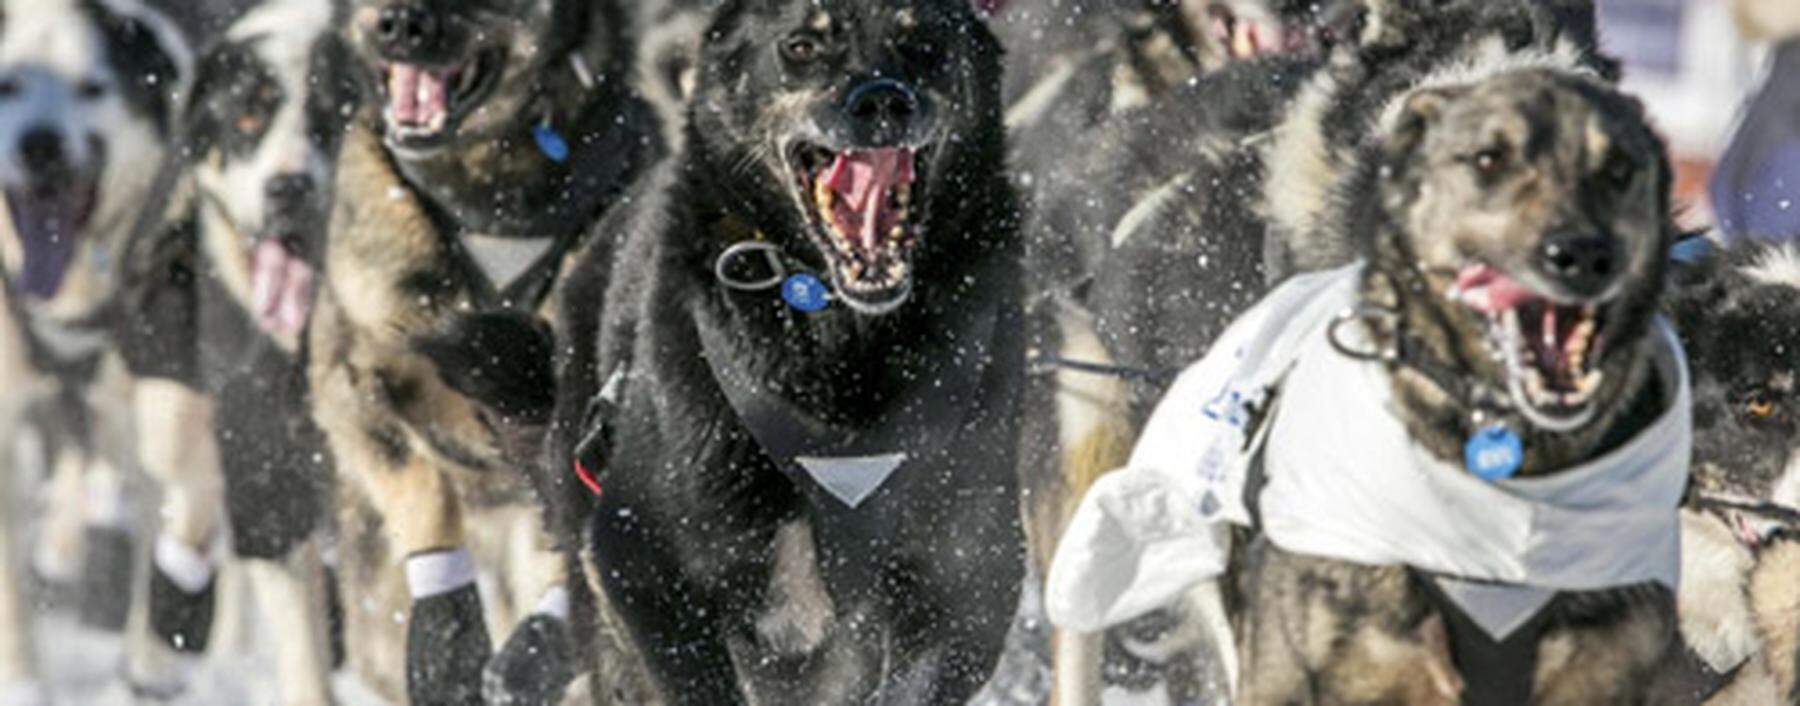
1235, 63, 1676, 704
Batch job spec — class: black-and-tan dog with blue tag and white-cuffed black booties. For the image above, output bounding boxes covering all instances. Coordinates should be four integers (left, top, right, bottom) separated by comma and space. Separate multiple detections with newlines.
306, 0, 662, 704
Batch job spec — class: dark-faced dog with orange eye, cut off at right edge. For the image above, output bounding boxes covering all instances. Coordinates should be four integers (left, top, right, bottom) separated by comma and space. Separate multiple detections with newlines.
1667, 243, 1800, 706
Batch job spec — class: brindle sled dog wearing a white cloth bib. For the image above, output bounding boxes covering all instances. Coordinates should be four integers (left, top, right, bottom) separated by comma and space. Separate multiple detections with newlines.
1048, 63, 1692, 704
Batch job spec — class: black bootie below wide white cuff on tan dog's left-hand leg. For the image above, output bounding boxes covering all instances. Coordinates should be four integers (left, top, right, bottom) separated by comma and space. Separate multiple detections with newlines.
407, 584, 493, 706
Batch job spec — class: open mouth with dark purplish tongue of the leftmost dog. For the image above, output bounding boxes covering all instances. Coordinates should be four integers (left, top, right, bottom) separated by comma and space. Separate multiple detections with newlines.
5, 178, 99, 299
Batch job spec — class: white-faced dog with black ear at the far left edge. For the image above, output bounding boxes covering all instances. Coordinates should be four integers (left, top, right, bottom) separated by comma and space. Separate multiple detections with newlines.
0, 0, 194, 704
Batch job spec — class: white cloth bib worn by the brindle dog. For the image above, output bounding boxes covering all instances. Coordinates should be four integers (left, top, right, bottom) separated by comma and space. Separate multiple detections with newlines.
1046, 267, 1692, 639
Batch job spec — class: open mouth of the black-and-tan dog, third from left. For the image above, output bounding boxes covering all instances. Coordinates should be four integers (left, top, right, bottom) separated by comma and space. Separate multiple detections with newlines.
382, 50, 500, 142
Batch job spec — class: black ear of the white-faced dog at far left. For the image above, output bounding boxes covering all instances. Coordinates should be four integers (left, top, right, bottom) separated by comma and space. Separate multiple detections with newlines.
86, 0, 194, 133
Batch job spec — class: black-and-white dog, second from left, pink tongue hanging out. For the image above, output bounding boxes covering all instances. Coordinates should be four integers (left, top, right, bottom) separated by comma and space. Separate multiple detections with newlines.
114, 0, 356, 704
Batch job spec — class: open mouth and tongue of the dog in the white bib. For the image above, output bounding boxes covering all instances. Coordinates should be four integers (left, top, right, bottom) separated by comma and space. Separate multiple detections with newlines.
1451, 263, 1607, 430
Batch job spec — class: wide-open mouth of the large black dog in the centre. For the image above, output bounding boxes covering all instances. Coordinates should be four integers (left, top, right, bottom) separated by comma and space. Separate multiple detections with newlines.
788, 146, 920, 313
